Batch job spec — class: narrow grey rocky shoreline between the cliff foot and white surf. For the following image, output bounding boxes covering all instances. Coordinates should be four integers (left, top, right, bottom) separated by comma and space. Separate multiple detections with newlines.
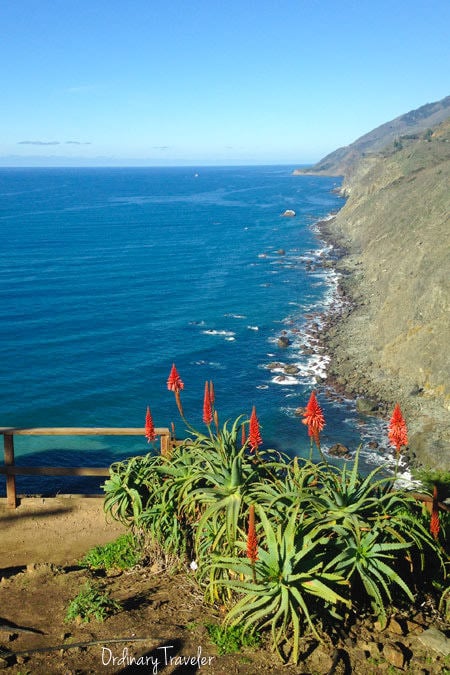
316, 201, 449, 470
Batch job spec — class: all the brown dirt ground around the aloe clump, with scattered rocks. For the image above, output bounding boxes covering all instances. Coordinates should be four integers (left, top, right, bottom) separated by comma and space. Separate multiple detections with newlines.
0, 496, 450, 675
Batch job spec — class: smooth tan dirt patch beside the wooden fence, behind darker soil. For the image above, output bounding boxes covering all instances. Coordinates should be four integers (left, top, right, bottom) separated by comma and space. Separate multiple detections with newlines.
0, 495, 125, 572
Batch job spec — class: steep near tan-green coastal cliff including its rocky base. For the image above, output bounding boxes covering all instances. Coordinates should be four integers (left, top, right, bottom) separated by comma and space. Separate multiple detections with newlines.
298, 104, 450, 470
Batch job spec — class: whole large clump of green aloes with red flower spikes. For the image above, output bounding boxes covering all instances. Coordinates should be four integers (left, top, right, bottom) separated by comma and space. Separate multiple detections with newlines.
104, 378, 448, 662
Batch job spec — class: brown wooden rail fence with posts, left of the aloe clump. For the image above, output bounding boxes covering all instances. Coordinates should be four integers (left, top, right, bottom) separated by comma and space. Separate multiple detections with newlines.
0, 427, 171, 508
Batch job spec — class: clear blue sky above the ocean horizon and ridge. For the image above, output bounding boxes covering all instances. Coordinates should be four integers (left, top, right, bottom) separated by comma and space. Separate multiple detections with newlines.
0, 0, 450, 166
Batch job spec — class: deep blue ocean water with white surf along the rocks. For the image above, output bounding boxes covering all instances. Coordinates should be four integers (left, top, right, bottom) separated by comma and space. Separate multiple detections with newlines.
0, 166, 386, 492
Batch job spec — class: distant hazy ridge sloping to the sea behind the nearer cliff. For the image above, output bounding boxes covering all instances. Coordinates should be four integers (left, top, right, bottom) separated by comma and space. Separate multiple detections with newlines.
294, 96, 450, 176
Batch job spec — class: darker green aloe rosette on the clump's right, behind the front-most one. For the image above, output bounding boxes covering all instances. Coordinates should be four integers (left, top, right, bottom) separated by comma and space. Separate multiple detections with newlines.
312, 451, 442, 623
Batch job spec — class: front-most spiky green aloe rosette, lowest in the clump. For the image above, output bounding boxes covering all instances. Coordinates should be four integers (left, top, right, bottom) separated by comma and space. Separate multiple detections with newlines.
212, 507, 349, 663
